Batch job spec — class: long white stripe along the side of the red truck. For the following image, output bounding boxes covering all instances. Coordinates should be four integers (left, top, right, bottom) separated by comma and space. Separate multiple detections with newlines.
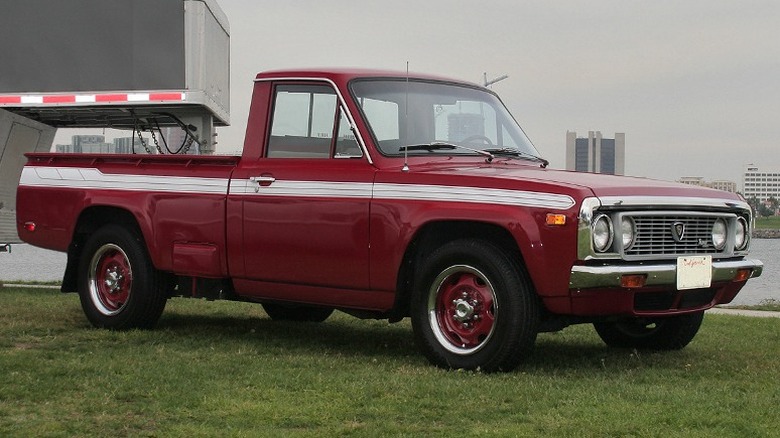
19, 167, 575, 210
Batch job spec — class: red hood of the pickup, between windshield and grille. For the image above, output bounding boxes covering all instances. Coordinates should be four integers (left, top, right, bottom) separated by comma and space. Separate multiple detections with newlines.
412, 161, 741, 201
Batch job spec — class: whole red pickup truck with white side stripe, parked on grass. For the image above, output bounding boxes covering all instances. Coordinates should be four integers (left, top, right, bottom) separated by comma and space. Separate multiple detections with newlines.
17, 70, 763, 371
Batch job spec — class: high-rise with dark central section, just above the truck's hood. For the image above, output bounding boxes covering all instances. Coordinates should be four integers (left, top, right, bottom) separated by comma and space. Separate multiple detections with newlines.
566, 131, 626, 175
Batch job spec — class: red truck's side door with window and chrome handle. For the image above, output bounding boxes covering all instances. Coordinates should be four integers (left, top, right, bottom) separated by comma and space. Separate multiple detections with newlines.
232, 83, 374, 290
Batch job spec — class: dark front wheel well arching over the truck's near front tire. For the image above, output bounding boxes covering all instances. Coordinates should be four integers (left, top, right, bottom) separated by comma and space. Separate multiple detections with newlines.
391, 221, 525, 320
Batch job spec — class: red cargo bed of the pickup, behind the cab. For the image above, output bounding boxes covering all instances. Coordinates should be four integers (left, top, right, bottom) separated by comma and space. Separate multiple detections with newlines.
18, 153, 240, 277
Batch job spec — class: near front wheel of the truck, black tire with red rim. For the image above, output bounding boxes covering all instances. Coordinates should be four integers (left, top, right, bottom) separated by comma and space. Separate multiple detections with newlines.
411, 239, 539, 372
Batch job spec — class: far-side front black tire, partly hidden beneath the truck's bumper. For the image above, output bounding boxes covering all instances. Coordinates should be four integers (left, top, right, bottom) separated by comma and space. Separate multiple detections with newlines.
593, 312, 704, 350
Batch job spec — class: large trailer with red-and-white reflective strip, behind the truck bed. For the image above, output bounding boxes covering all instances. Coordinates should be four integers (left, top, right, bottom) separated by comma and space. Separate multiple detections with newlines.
0, 0, 230, 246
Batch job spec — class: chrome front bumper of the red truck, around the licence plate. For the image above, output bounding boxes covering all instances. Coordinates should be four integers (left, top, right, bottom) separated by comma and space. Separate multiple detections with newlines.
569, 260, 764, 289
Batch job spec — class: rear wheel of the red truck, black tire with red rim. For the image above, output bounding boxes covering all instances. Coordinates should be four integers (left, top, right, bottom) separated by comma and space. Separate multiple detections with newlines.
78, 225, 167, 330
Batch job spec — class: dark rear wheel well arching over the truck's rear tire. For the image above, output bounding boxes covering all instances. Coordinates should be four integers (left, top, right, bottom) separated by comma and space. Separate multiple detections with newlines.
62, 206, 143, 292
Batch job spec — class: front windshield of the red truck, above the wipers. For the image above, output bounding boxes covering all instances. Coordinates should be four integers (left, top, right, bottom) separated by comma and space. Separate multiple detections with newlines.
351, 79, 539, 157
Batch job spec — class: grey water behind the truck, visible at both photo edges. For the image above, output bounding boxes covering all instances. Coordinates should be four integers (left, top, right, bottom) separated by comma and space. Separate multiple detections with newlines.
0, 239, 780, 305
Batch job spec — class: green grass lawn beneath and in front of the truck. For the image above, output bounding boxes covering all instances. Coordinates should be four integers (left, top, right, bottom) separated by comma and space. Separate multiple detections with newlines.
0, 288, 780, 437
